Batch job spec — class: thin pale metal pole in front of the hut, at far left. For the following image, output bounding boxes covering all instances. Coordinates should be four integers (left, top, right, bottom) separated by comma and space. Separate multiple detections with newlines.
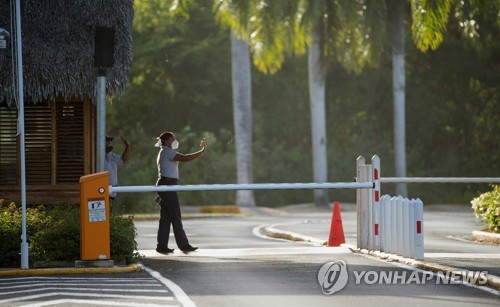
16, 0, 29, 270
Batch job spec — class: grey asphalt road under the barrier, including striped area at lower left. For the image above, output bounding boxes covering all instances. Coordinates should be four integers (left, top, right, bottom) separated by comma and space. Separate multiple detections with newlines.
0, 207, 500, 307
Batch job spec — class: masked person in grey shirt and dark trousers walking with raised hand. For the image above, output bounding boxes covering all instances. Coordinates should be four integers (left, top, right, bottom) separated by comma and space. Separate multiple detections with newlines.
155, 132, 206, 254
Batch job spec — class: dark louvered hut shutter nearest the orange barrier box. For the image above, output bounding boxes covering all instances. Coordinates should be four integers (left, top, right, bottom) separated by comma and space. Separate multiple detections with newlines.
56, 101, 85, 184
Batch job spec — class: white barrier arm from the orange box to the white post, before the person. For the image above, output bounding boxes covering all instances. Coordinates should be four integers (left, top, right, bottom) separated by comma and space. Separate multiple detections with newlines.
109, 182, 374, 193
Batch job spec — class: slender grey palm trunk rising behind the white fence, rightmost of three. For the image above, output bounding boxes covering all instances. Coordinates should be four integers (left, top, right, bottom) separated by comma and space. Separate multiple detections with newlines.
392, 1, 408, 197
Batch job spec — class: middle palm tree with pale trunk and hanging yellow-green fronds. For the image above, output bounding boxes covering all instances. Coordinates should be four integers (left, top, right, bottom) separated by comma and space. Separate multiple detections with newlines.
216, 0, 377, 206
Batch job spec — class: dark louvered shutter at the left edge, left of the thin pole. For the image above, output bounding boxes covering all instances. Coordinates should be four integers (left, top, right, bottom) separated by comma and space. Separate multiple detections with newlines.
0, 105, 17, 185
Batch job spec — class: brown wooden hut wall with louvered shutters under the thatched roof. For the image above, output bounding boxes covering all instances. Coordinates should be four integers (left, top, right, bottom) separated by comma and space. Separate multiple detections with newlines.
0, 100, 95, 204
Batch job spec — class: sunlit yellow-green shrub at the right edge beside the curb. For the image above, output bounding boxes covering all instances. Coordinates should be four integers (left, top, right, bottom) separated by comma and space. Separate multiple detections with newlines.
471, 185, 500, 233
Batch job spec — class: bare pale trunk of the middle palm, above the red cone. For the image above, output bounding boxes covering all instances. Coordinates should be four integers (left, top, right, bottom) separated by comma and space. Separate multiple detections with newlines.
308, 29, 328, 207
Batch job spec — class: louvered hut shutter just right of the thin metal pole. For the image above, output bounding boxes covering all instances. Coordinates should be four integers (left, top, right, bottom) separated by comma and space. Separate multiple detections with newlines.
24, 105, 52, 185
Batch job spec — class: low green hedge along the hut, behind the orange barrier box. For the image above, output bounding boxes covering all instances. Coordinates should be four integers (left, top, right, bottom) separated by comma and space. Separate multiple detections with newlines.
0, 200, 140, 267
